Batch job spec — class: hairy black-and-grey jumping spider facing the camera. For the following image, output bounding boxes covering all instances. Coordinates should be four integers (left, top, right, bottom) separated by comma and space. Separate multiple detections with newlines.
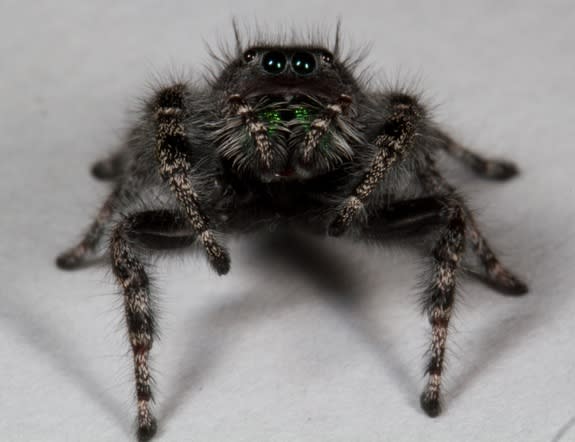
57, 28, 527, 440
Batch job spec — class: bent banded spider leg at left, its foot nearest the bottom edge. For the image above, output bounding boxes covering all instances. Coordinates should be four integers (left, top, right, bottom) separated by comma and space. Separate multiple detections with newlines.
110, 211, 195, 441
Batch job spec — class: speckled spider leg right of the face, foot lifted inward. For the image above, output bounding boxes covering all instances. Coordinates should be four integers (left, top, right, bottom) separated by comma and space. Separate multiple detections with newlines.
328, 94, 422, 236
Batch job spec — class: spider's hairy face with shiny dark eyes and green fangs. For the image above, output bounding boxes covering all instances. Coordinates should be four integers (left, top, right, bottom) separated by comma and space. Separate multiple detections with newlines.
214, 46, 358, 182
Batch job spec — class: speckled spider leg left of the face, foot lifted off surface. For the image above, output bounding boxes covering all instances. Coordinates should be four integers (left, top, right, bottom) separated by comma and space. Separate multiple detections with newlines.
154, 85, 230, 275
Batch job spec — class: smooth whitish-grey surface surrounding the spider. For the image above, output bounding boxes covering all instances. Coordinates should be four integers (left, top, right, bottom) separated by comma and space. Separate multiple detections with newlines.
0, 0, 575, 442
